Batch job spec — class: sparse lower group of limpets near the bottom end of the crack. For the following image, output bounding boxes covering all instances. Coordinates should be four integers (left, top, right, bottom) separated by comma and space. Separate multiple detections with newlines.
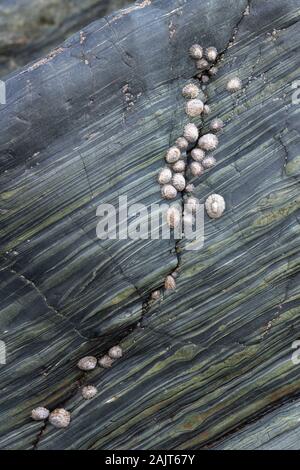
31, 346, 123, 428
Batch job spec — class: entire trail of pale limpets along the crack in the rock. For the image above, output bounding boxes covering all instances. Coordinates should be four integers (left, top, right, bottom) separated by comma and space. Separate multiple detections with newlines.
31, 44, 242, 428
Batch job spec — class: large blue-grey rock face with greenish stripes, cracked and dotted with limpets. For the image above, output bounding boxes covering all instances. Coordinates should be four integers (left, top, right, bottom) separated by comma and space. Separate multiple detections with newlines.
0, 0, 300, 449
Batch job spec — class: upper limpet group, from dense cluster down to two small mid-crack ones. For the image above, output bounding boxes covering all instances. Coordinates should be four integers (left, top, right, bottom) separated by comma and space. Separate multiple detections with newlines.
151, 44, 242, 300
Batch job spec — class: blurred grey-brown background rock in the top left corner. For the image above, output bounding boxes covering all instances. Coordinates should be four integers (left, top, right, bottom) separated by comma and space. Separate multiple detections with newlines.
0, 0, 130, 77
